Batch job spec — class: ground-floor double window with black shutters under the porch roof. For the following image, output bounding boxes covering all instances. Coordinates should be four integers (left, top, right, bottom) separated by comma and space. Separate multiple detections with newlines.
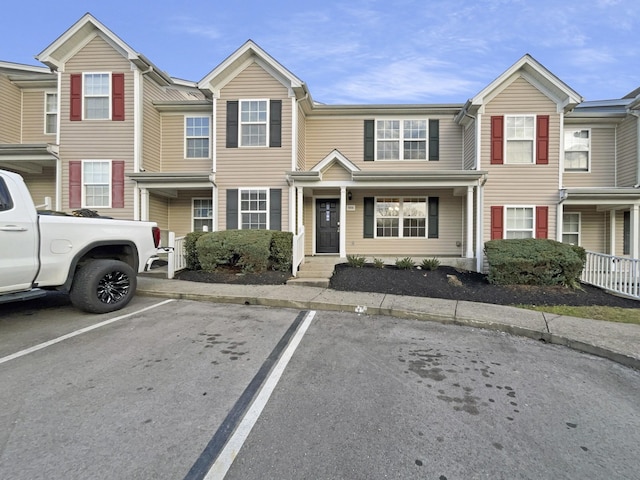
375, 198, 427, 238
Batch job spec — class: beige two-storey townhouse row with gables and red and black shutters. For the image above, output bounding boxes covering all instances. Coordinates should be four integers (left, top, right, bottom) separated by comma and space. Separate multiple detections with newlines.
0, 14, 640, 271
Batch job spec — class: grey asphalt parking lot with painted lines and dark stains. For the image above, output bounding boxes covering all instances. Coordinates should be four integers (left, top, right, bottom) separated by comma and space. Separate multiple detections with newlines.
0, 296, 640, 480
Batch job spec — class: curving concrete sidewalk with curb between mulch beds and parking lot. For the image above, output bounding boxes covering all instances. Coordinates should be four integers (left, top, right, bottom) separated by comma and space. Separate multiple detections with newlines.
138, 276, 640, 370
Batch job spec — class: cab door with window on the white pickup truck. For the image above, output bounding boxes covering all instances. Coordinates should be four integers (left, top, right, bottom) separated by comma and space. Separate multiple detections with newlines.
0, 176, 38, 293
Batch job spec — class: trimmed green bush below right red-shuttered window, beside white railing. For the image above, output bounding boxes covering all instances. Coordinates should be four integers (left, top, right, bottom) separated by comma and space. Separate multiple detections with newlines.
484, 238, 586, 288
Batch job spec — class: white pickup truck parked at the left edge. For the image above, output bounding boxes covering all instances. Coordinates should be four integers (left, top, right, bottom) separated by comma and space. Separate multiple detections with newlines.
0, 170, 160, 313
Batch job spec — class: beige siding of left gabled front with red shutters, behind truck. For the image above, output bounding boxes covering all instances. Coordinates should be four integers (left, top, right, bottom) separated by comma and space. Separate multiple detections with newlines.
59, 36, 134, 218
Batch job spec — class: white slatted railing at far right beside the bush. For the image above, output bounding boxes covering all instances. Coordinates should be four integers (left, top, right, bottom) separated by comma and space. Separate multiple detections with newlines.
580, 252, 640, 298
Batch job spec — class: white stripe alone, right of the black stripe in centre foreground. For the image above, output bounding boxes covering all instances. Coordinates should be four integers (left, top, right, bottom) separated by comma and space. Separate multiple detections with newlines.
205, 310, 316, 480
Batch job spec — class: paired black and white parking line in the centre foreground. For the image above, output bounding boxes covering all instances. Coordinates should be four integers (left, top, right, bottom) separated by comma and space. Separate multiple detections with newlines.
185, 310, 316, 480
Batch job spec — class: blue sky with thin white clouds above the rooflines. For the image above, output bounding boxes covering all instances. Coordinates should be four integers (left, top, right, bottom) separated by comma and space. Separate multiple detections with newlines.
0, 0, 640, 104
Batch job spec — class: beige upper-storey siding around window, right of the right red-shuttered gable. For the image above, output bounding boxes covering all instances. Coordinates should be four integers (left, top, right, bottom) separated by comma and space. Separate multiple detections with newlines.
563, 125, 616, 188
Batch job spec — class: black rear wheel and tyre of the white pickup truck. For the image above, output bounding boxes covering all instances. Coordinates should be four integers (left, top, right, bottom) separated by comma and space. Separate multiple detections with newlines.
70, 260, 137, 313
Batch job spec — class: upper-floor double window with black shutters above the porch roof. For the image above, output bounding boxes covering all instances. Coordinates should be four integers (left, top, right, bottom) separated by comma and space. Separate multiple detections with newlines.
376, 120, 427, 160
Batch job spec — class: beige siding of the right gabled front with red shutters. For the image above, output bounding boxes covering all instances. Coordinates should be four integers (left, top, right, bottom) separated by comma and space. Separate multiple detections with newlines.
481, 78, 560, 241
